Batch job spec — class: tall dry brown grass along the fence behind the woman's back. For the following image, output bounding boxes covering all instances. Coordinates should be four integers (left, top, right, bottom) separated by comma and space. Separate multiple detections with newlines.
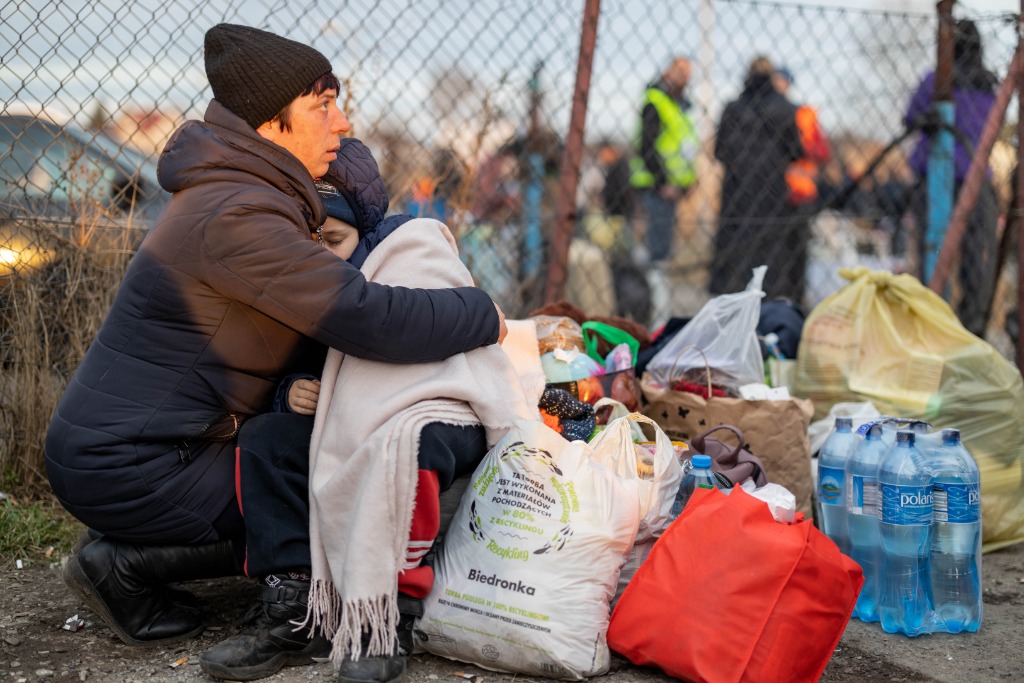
0, 201, 141, 499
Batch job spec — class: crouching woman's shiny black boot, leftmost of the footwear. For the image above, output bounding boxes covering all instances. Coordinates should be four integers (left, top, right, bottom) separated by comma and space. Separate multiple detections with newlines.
63, 537, 238, 645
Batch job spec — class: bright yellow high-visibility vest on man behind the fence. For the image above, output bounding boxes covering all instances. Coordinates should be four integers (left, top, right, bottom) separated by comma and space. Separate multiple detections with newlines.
630, 88, 700, 187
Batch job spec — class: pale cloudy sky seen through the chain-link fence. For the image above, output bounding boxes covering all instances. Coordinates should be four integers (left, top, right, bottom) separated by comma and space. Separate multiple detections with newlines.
0, 0, 1020, 157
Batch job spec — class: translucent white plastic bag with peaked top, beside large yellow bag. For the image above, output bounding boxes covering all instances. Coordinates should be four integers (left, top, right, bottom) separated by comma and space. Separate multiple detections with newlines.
646, 265, 768, 387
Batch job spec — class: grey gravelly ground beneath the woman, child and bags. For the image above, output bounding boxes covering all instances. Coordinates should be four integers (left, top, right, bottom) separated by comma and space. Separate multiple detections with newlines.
0, 544, 1024, 683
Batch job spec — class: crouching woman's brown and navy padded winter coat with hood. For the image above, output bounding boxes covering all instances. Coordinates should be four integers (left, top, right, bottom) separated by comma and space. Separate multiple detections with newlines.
45, 100, 499, 543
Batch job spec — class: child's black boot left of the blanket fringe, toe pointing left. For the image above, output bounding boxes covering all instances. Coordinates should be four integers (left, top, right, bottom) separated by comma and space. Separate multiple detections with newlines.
199, 579, 331, 681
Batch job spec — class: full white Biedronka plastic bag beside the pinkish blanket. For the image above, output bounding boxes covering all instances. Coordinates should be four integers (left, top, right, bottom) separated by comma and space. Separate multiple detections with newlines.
415, 421, 640, 679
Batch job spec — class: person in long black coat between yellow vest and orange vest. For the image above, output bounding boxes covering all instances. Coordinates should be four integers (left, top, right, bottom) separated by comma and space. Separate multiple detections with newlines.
711, 56, 809, 303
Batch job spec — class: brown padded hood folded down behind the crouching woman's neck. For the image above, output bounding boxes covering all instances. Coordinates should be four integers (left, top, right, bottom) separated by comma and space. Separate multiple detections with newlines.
157, 99, 323, 231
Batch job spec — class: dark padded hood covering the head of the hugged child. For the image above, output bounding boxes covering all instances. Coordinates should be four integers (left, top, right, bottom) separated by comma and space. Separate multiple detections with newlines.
323, 137, 390, 234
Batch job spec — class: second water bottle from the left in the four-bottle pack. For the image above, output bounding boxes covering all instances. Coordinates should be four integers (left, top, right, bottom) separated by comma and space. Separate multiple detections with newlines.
846, 424, 889, 622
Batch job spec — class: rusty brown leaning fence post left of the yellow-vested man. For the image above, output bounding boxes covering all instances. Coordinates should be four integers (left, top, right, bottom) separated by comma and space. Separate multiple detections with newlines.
544, 0, 601, 303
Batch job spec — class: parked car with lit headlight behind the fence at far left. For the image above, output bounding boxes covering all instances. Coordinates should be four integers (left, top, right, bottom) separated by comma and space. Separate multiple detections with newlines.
0, 115, 170, 274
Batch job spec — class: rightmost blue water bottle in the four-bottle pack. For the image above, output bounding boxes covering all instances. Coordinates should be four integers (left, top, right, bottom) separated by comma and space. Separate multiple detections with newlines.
927, 429, 982, 633
